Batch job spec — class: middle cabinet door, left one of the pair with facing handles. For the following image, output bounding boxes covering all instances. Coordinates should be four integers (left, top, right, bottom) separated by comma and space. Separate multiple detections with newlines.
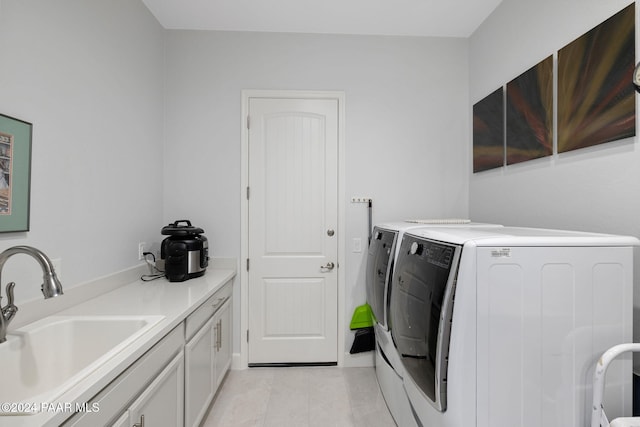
184, 318, 215, 427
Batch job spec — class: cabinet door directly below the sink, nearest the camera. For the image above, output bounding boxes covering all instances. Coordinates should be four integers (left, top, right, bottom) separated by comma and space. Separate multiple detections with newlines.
129, 352, 184, 427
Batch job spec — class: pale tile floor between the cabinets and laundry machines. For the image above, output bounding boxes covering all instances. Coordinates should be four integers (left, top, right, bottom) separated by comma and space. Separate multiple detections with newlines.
202, 367, 396, 427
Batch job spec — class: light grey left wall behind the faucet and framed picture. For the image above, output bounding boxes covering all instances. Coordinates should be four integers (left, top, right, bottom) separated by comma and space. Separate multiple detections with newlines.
0, 0, 164, 303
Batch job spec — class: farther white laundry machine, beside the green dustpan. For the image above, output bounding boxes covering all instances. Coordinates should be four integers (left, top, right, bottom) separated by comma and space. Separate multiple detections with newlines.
366, 219, 500, 427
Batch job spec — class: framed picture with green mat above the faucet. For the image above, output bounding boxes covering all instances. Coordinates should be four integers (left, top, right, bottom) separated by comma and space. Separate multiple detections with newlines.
0, 114, 33, 233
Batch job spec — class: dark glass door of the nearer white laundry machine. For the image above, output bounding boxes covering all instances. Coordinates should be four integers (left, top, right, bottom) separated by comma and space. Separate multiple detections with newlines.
391, 234, 461, 411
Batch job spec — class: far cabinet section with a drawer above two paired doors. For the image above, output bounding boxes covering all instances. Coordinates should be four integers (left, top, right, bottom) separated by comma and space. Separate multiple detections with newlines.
184, 284, 232, 427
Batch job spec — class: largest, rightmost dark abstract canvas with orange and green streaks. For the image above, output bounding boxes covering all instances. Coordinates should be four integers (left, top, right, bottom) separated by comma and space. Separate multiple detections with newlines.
558, 4, 636, 153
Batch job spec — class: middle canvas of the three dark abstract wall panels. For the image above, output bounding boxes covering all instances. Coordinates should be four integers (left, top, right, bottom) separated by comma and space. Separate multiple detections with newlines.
506, 56, 553, 165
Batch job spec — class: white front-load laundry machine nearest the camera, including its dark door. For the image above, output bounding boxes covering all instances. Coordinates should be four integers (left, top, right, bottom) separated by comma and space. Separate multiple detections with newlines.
388, 227, 640, 427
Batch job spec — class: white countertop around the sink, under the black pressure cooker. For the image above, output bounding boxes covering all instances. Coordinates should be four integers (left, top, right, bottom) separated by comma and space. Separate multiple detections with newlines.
0, 267, 236, 427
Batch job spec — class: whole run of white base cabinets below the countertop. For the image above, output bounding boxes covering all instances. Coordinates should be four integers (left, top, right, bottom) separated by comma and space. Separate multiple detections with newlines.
60, 280, 233, 427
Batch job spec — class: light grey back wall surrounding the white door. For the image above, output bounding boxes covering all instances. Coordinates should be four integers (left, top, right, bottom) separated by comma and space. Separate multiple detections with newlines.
164, 31, 469, 351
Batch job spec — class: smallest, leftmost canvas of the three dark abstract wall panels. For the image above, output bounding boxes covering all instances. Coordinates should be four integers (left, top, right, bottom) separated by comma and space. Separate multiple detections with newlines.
473, 88, 504, 173
